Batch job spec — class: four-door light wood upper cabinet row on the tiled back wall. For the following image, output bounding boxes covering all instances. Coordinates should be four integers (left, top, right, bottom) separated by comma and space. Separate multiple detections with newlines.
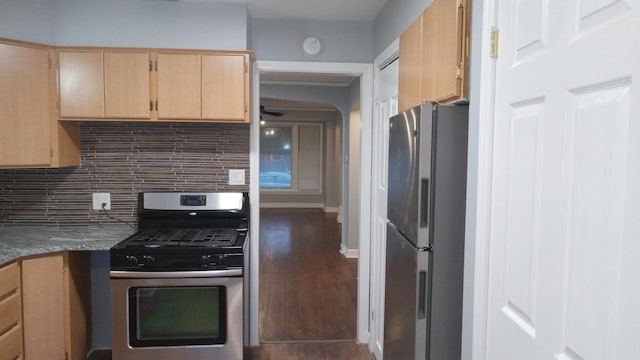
59, 49, 251, 122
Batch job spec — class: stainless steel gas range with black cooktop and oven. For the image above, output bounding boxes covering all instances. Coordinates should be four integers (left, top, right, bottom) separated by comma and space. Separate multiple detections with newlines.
110, 192, 249, 360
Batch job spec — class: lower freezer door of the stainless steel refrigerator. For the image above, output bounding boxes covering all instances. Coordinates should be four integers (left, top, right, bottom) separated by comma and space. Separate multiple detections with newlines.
383, 224, 429, 360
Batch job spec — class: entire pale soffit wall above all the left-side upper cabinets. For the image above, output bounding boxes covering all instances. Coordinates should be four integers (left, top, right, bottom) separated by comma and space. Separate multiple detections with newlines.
0, 0, 248, 50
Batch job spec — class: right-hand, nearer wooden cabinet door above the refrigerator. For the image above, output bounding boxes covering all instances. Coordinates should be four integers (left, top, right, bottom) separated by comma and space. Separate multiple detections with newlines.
421, 0, 466, 102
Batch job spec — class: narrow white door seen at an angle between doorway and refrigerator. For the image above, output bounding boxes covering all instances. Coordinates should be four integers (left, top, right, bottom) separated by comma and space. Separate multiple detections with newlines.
370, 59, 398, 359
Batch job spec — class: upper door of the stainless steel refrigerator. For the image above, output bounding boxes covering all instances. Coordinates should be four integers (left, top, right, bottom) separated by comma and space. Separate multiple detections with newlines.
387, 103, 433, 247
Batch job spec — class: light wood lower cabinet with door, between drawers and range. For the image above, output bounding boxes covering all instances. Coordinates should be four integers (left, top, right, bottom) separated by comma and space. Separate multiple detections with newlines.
22, 252, 91, 360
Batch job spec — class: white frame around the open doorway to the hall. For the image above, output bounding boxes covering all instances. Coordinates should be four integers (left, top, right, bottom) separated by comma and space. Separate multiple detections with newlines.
248, 61, 373, 346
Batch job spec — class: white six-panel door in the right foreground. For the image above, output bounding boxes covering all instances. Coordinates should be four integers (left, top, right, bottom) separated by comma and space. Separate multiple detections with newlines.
485, 0, 640, 360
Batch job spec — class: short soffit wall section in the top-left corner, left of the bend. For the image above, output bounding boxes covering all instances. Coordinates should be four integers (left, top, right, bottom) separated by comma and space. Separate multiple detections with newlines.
0, 0, 53, 44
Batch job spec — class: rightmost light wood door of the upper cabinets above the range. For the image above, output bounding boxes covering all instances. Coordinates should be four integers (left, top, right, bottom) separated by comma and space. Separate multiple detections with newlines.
202, 55, 249, 121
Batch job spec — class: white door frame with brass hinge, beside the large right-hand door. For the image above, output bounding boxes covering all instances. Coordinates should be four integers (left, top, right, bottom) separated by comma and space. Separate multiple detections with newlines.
468, 0, 508, 360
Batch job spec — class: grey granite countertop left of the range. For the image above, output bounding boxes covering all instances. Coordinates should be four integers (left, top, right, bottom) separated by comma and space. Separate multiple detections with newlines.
0, 225, 135, 265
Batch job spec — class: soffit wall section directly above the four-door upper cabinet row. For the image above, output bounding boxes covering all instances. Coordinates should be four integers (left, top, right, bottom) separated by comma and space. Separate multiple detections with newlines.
52, 0, 247, 50
